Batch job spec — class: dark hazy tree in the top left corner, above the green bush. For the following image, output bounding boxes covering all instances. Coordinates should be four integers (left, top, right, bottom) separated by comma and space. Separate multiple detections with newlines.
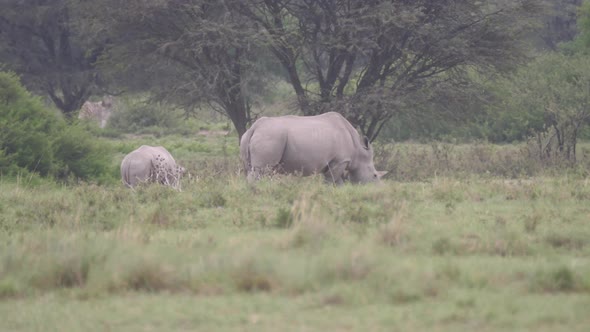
0, 0, 104, 118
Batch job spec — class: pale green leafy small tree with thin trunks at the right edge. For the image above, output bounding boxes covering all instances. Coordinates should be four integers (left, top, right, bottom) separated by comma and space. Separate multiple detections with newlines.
502, 53, 590, 162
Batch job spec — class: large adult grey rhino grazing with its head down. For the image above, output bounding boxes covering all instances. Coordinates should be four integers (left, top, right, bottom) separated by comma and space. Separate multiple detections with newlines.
240, 112, 386, 184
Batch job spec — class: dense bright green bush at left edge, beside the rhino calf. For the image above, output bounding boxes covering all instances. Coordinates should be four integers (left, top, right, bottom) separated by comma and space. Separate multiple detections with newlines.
0, 72, 112, 180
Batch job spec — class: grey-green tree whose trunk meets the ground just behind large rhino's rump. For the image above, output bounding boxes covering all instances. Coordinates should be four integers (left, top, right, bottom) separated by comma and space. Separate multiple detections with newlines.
85, 0, 266, 137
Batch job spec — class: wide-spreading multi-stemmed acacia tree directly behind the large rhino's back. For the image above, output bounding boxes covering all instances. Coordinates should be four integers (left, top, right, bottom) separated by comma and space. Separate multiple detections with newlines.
240, 0, 542, 140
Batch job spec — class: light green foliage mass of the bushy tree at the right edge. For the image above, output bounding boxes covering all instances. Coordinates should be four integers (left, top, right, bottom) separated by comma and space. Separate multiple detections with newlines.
484, 53, 590, 160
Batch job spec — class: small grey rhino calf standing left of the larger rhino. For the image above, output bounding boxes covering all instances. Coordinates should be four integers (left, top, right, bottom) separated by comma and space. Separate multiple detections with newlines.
121, 145, 184, 190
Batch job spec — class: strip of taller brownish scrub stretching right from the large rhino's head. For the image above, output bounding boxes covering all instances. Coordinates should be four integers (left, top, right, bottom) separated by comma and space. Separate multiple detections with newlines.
375, 142, 590, 181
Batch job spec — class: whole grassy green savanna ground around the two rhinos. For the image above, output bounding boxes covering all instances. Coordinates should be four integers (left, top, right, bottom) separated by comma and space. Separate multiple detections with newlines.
0, 130, 590, 331
